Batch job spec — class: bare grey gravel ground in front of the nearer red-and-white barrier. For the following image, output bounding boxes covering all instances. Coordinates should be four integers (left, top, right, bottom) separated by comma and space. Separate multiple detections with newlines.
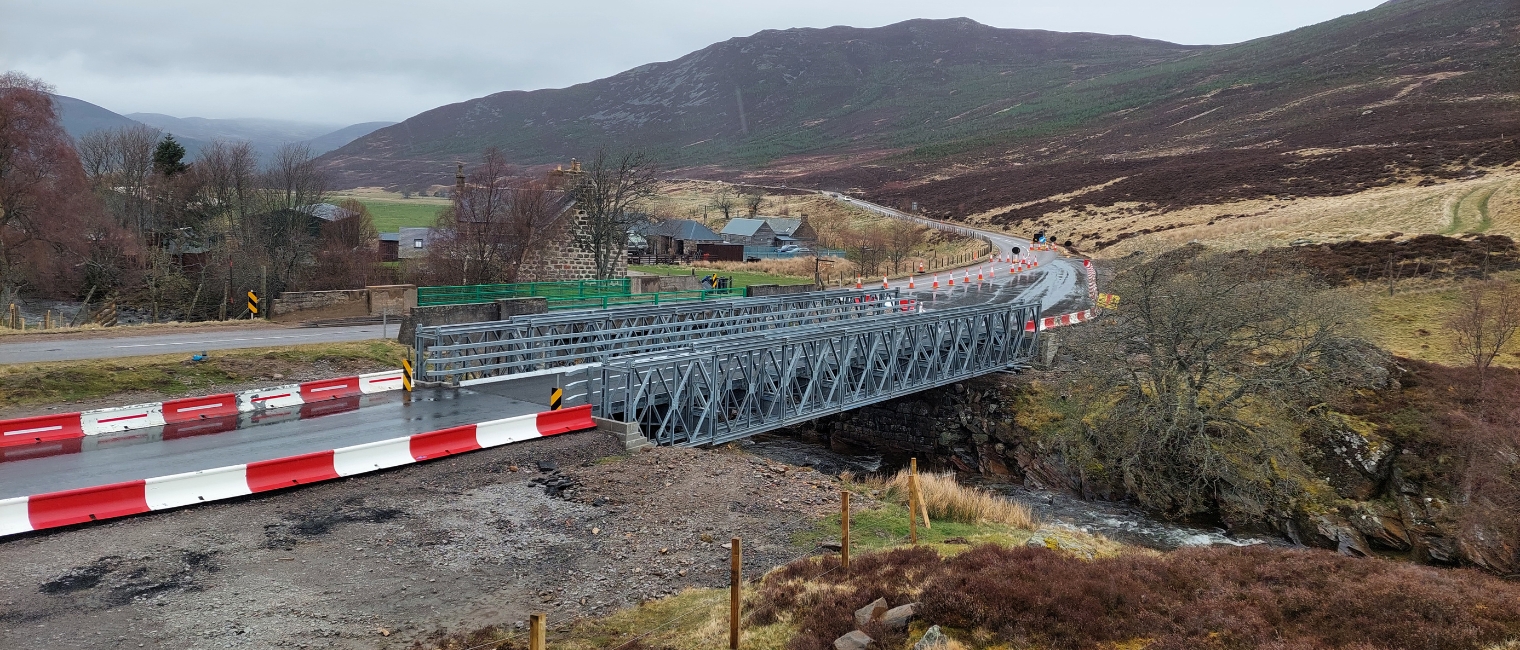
0, 431, 838, 648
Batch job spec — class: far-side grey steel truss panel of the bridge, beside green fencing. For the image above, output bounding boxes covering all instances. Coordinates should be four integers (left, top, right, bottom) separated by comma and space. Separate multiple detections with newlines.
416, 289, 914, 383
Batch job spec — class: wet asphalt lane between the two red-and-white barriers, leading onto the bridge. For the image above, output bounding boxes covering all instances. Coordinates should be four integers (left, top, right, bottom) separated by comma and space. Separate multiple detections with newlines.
0, 389, 546, 498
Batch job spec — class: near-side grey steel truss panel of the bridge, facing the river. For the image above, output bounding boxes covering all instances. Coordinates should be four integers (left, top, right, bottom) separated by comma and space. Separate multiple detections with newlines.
587, 304, 1040, 445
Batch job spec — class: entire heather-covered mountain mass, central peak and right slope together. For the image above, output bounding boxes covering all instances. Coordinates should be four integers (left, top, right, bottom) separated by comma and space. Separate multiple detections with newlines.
322, 0, 1520, 212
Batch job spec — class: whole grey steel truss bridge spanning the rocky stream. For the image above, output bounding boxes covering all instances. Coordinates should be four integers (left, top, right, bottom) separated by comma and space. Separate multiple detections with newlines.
416, 290, 1040, 445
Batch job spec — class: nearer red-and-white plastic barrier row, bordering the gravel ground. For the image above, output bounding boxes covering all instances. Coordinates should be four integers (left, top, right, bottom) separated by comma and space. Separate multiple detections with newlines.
0, 405, 596, 536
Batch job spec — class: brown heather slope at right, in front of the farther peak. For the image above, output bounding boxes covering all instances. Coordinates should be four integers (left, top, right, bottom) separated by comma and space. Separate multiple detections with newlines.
857, 0, 1520, 230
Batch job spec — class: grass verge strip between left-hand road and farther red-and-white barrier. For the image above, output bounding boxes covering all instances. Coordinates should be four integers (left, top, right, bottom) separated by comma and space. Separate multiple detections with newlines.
0, 340, 406, 409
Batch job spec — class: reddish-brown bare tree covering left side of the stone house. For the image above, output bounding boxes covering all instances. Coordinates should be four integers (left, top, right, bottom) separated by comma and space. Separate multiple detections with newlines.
427, 149, 570, 284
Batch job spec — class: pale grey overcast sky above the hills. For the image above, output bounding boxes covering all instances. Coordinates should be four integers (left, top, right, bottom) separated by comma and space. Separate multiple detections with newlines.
0, 0, 1382, 123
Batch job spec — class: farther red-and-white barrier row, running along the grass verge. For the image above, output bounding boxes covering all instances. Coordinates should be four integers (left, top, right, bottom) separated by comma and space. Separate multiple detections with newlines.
0, 371, 401, 446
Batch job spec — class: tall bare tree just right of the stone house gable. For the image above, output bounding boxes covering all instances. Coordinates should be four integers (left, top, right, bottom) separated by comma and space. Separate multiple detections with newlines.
573, 147, 660, 279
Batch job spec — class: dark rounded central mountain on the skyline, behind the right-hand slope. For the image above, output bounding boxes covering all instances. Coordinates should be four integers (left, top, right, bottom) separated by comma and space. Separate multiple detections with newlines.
325, 18, 1201, 185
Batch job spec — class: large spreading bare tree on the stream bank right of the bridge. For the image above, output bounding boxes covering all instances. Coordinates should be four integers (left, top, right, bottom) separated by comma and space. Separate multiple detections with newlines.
1052, 246, 1386, 519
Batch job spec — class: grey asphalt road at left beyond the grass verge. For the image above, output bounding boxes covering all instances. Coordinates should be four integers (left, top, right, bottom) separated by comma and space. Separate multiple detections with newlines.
0, 323, 397, 363
